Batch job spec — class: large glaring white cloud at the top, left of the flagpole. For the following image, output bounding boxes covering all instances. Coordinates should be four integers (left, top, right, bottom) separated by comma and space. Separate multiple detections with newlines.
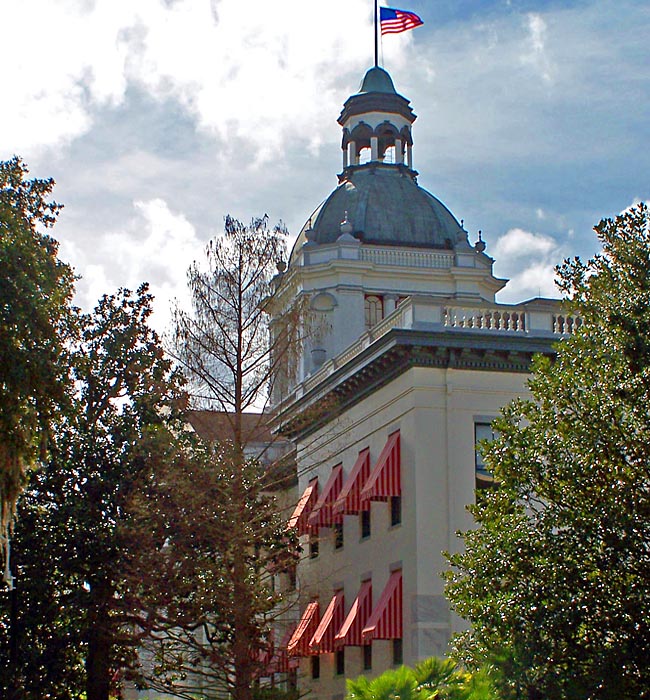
0, 0, 380, 162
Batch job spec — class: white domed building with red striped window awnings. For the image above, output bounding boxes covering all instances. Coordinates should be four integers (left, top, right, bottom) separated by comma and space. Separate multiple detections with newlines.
272, 67, 577, 700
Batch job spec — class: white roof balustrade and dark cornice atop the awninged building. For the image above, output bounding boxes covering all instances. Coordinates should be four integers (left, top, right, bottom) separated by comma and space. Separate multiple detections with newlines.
275, 297, 581, 440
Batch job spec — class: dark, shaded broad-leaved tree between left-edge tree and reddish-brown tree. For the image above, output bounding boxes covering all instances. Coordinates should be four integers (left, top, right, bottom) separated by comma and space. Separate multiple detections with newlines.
0, 285, 183, 700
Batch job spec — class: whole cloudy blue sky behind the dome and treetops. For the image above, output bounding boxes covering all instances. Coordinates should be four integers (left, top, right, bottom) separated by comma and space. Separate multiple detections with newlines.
0, 0, 650, 330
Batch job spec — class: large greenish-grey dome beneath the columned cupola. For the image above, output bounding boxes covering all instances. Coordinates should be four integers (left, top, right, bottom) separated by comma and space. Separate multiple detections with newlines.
294, 163, 467, 260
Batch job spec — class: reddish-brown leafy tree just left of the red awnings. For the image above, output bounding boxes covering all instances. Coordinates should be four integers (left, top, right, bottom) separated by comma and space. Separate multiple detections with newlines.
125, 430, 295, 699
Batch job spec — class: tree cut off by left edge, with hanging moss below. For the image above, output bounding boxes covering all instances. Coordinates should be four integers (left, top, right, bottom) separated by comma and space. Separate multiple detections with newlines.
0, 157, 73, 583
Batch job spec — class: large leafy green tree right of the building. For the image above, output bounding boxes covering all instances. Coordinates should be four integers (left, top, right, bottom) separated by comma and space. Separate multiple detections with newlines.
447, 205, 650, 699
